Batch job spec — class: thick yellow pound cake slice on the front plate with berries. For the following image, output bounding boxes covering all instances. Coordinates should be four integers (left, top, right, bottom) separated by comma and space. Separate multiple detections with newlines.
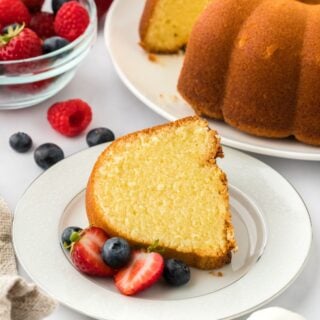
86, 117, 236, 269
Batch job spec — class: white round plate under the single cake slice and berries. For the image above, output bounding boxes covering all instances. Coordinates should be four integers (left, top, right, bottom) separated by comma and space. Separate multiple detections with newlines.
13, 145, 312, 320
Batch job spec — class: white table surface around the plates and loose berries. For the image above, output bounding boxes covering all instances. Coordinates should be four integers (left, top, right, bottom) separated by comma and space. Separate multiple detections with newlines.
0, 27, 320, 320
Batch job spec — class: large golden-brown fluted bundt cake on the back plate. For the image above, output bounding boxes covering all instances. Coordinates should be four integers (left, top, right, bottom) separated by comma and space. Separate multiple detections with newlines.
178, 0, 320, 145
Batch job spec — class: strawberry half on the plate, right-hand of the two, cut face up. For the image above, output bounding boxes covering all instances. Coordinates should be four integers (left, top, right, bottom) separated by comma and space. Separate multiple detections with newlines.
114, 251, 164, 296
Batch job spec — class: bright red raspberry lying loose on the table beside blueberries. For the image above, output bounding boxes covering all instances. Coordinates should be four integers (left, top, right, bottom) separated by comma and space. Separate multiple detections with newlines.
47, 99, 92, 137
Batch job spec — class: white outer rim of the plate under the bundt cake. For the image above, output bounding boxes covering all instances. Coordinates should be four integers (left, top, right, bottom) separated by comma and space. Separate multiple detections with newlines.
104, 0, 320, 161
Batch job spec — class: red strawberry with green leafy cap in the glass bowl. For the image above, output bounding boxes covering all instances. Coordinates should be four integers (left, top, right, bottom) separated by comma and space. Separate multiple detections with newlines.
0, 25, 42, 61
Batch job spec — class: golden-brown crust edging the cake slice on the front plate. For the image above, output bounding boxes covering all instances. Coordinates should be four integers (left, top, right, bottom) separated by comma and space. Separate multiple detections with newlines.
86, 116, 237, 269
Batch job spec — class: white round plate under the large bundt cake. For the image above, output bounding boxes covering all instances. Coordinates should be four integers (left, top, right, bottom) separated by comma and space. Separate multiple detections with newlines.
105, 0, 320, 161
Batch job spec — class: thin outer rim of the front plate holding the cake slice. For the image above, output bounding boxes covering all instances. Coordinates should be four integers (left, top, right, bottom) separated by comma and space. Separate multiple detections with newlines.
12, 143, 314, 320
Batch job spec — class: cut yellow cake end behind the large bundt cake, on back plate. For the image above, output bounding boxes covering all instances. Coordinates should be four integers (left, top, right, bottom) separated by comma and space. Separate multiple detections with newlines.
140, 0, 212, 53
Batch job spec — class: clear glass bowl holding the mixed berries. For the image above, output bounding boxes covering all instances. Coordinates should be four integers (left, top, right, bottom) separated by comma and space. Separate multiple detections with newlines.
0, 0, 97, 110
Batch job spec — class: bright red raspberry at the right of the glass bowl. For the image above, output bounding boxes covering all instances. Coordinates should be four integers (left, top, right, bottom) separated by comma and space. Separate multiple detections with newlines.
54, 1, 90, 41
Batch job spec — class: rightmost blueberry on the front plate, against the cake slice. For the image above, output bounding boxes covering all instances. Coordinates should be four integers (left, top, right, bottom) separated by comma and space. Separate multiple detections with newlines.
163, 259, 190, 286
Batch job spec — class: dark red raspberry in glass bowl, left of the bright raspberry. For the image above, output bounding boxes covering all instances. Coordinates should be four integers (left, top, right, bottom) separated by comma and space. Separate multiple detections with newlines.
29, 12, 55, 39
